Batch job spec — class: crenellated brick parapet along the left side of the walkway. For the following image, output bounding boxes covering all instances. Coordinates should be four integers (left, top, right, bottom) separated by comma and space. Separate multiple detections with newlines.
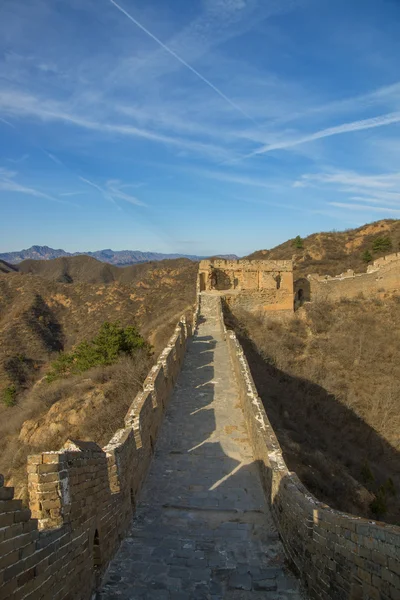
0, 306, 198, 600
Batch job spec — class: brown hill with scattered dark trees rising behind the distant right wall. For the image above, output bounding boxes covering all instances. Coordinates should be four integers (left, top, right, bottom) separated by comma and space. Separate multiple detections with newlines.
246, 219, 400, 277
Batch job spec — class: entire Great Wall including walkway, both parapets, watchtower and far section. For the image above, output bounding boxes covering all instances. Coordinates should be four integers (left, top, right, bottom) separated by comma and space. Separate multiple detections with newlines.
0, 255, 400, 600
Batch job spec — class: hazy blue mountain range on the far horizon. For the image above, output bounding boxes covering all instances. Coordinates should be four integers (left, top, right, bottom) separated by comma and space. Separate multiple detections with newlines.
0, 246, 238, 266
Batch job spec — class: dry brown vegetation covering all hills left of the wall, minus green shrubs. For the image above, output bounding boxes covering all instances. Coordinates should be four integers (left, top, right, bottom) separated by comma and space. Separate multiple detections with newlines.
0, 257, 197, 497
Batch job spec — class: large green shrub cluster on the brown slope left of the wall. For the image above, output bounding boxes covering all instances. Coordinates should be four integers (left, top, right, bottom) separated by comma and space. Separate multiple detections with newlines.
46, 322, 150, 382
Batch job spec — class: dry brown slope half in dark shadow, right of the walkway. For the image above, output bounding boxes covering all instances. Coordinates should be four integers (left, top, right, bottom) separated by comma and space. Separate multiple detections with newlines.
226, 297, 400, 524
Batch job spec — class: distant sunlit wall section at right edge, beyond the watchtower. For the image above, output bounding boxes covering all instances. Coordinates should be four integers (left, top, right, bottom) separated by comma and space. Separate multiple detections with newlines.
306, 253, 400, 301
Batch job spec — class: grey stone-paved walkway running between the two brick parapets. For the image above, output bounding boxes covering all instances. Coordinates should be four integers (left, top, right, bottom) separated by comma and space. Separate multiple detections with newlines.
98, 294, 302, 600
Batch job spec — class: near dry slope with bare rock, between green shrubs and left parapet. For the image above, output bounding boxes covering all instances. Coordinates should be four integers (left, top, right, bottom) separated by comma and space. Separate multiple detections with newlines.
0, 351, 152, 501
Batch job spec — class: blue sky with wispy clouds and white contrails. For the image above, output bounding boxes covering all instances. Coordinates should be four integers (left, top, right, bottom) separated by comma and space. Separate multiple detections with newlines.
0, 0, 400, 255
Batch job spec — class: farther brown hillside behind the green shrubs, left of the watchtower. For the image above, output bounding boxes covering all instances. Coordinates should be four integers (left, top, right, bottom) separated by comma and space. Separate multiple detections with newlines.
0, 256, 197, 391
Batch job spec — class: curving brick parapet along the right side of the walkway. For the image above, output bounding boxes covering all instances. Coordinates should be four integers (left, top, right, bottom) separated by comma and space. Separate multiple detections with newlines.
221, 298, 400, 600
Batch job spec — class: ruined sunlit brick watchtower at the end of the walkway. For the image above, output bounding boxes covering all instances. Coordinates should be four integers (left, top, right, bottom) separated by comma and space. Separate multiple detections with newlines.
198, 258, 293, 311
